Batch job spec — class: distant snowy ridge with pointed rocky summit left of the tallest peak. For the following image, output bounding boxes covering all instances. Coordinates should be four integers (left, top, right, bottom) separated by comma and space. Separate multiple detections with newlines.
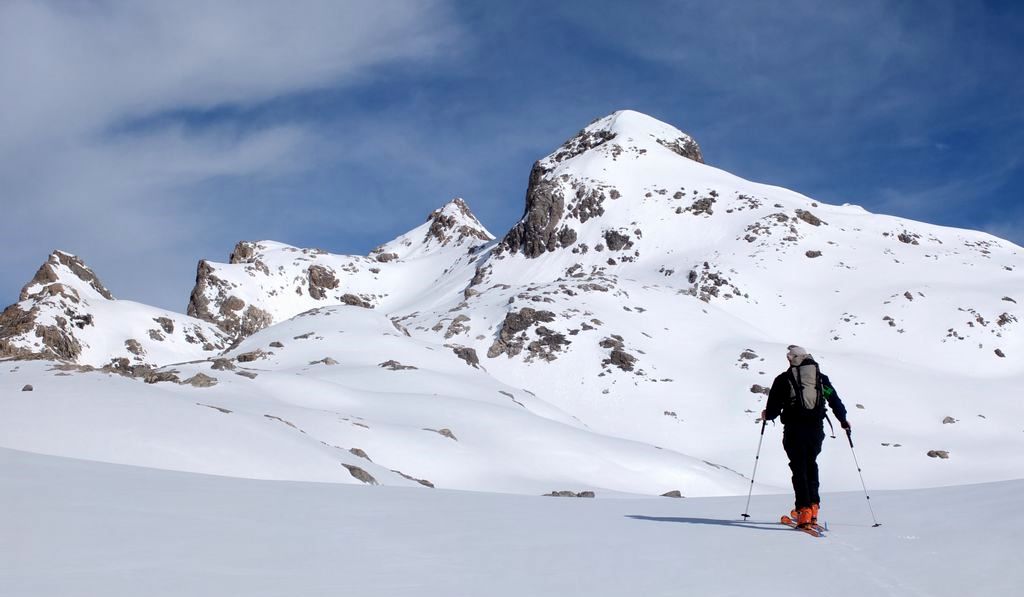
188, 199, 494, 338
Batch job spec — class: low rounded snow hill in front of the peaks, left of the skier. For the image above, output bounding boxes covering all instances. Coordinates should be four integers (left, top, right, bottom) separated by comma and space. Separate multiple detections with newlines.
0, 305, 749, 495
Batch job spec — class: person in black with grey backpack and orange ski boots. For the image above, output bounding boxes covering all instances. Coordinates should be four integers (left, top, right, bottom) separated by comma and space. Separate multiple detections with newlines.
761, 346, 850, 526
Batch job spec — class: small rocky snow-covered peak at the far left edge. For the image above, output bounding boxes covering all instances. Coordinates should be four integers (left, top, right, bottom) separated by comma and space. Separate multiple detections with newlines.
0, 251, 228, 371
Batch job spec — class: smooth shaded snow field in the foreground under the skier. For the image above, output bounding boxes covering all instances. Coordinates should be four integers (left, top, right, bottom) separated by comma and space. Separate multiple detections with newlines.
0, 450, 1024, 597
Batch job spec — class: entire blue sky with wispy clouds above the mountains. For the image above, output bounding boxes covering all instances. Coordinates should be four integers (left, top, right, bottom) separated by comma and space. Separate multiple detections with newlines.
0, 0, 1024, 310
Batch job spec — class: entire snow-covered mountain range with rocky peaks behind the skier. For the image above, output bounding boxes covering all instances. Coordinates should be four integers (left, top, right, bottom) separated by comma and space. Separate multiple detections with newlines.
0, 111, 1024, 496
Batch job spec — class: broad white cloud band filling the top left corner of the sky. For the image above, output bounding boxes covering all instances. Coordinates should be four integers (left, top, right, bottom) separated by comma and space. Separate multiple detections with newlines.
0, 0, 455, 150
